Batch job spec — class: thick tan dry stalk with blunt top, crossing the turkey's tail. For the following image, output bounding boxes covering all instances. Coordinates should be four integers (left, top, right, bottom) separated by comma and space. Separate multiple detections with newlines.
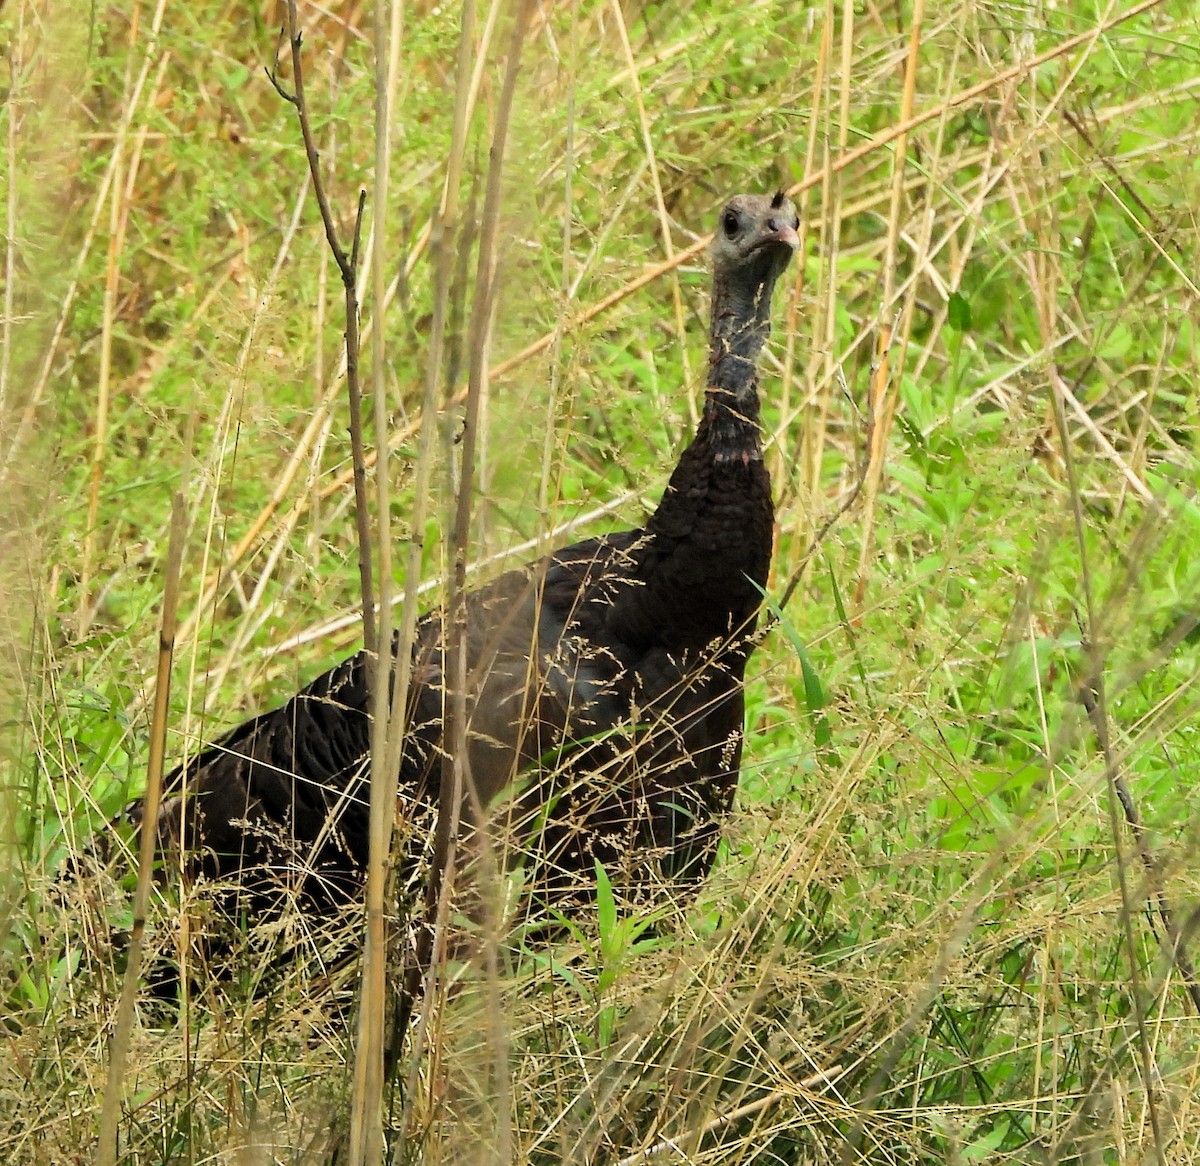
96, 477, 188, 1166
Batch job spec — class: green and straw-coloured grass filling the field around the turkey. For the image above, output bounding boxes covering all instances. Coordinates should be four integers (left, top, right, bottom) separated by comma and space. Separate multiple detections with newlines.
0, 0, 1200, 1164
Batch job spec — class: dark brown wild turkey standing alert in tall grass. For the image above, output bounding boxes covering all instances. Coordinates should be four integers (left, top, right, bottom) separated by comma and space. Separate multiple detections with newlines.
147, 193, 798, 930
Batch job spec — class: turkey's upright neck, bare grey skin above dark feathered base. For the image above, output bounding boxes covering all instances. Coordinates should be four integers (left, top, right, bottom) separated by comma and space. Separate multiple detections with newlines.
611, 266, 775, 671
